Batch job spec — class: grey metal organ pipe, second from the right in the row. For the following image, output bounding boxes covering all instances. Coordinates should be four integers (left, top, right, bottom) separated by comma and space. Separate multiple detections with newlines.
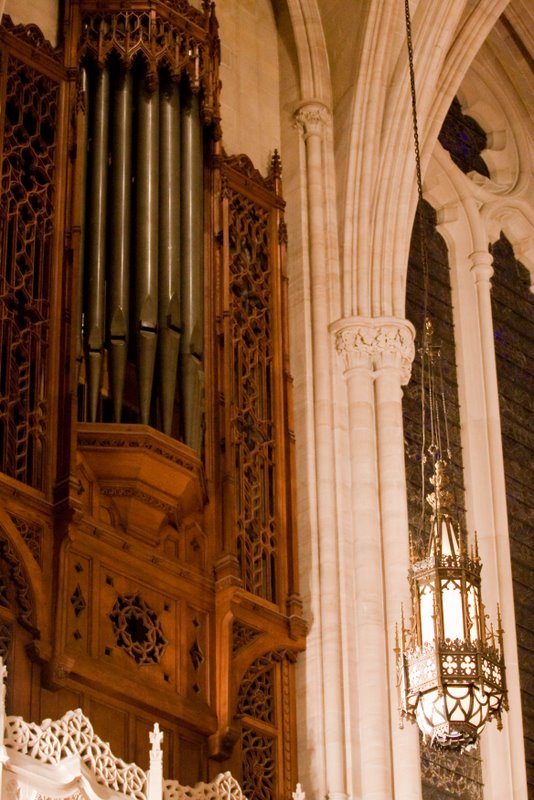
158, 81, 181, 435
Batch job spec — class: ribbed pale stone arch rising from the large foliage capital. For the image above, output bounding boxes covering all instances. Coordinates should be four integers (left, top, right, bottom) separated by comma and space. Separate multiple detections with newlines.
343, 0, 506, 317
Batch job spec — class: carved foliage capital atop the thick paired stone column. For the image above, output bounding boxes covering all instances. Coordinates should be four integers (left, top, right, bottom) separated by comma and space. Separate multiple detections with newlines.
331, 317, 415, 386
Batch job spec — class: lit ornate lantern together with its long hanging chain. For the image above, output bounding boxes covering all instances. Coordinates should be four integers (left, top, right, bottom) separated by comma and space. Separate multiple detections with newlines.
402, 0, 508, 750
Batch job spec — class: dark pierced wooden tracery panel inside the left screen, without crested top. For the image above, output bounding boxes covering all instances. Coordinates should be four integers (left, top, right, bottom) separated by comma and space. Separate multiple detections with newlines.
0, 54, 59, 489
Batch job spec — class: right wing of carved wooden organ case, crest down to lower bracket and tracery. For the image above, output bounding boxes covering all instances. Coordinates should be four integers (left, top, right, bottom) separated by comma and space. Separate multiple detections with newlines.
210, 153, 306, 800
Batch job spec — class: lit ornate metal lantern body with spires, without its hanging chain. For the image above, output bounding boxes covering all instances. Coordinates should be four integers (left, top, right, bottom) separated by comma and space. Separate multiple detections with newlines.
396, 459, 507, 749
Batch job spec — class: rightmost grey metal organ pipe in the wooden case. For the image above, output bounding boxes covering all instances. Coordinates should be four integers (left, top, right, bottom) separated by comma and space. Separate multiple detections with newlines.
180, 94, 204, 450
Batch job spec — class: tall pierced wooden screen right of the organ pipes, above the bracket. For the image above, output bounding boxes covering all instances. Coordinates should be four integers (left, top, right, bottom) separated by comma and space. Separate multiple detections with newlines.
219, 154, 296, 607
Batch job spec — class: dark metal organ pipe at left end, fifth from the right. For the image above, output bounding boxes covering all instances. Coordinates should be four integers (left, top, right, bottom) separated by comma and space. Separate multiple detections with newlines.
86, 69, 109, 422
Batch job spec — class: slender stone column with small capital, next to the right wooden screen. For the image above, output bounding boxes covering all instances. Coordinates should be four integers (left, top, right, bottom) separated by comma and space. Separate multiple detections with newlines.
296, 102, 348, 800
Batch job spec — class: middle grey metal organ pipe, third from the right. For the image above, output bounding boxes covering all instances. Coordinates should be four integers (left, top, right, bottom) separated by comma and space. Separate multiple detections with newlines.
136, 74, 159, 425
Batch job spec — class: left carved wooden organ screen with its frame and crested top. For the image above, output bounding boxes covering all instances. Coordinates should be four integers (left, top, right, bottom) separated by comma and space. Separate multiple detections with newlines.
0, 16, 66, 491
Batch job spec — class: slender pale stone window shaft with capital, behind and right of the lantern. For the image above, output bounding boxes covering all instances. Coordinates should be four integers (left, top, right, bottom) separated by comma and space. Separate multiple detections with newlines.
469, 250, 527, 800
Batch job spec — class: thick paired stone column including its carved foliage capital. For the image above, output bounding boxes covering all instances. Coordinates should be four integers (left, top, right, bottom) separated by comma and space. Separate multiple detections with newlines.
332, 317, 421, 800
